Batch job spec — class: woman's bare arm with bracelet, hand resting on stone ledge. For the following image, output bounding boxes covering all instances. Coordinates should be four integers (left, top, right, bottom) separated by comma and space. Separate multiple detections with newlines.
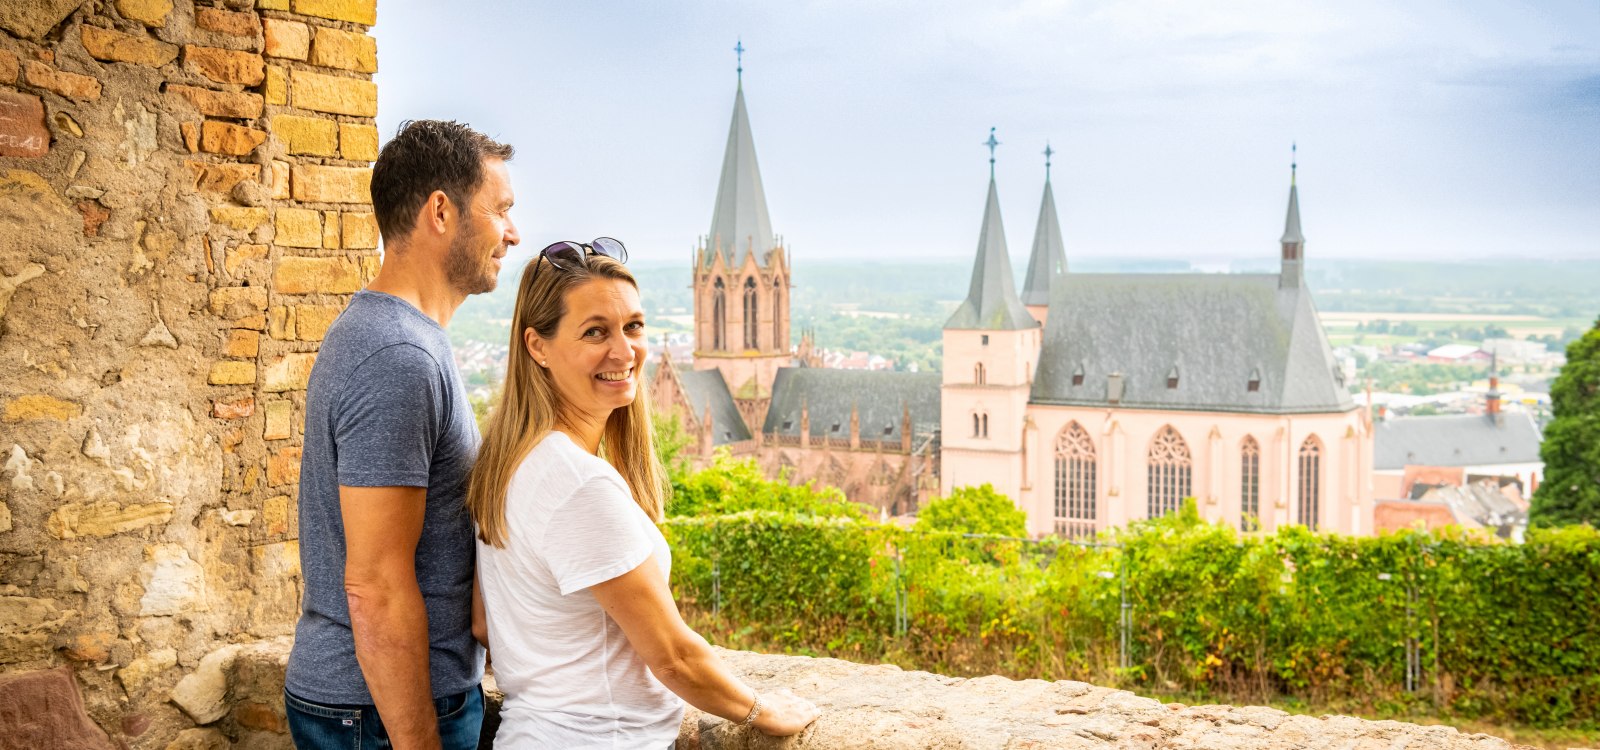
590, 555, 818, 736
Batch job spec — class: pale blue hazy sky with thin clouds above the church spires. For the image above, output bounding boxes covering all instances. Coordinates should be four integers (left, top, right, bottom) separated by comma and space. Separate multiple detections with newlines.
374, 0, 1600, 265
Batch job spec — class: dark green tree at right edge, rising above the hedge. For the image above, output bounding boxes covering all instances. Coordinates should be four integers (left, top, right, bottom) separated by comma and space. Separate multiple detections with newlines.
1528, 320, 1600, 526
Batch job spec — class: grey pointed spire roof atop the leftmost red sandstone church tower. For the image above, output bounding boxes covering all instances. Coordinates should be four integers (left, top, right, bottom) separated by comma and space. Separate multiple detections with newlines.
701, 42, 778, 265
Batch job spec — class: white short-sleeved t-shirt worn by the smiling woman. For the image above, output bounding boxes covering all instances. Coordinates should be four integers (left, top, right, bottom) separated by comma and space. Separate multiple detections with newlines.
478, 432, 683, 748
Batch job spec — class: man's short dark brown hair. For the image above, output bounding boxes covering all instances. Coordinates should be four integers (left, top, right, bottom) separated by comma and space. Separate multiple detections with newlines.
373, 120, 515, 243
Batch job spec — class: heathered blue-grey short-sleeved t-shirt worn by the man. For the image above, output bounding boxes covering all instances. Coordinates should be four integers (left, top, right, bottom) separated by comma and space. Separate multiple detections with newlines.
285, 291, 483, 705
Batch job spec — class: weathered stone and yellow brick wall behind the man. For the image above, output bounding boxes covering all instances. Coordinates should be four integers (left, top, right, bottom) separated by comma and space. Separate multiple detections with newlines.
0, 0, 378, 748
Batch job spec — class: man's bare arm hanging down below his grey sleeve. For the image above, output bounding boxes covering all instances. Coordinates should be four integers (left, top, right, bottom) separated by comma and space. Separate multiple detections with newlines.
339, 486, 440, 750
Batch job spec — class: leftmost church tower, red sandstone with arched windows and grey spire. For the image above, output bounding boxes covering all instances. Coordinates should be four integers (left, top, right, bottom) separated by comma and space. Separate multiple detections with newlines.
693, 43, 790, 432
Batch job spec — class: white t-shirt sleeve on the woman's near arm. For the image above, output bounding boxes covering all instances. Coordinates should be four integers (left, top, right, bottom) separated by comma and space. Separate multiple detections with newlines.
541, 477, 651, 596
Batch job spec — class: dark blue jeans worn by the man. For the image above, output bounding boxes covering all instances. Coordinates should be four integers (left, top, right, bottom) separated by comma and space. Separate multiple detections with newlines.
283, 686, 483, 750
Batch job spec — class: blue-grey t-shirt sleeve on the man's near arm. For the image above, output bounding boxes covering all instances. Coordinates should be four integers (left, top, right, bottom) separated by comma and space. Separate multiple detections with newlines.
333, 344, 445, 488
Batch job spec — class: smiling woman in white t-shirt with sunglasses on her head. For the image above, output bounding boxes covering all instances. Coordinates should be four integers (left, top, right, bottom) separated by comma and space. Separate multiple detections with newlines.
467, 238, 818, 750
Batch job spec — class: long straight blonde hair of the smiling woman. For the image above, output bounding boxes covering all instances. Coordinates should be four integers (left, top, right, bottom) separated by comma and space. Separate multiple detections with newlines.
467, 256, 667, 547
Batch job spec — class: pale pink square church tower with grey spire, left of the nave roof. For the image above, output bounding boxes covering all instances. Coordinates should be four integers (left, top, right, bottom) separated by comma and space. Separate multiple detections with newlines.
939, 128, 1043, 502
